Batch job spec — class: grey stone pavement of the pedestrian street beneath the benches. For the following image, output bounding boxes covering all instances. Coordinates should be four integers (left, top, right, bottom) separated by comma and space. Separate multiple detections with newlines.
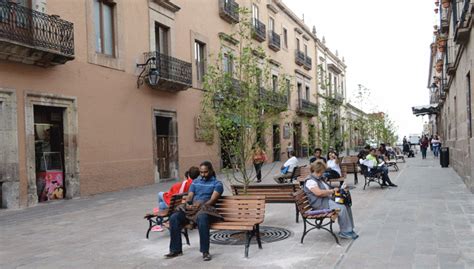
0, 152, 474, 269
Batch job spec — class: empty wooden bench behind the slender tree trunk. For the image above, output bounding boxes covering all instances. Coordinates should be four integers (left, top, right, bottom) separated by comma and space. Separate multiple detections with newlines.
231, 183, 300, 222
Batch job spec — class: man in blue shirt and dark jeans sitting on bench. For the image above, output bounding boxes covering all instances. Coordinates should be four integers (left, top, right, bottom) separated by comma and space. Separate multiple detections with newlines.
165, 161, 224, 261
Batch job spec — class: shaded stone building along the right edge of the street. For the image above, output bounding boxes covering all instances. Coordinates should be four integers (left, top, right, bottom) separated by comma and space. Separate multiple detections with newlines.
425, 0, 474, 191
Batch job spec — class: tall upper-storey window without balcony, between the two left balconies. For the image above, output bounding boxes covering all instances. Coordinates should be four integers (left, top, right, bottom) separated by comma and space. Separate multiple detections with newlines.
94, 0, 115, 56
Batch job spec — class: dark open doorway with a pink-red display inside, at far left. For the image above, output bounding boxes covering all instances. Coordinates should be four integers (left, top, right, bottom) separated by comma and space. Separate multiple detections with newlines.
33, 105, 65, 202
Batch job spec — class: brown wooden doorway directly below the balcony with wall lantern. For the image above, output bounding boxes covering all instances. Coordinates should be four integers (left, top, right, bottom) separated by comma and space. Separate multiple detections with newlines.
155, 111, 178, 181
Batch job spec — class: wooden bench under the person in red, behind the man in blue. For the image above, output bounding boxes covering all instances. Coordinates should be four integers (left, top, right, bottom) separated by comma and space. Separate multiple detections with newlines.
144, 193, 189, 242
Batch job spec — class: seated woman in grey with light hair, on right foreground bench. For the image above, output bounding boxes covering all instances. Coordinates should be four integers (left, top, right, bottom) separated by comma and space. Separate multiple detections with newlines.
303, 161, 359, 239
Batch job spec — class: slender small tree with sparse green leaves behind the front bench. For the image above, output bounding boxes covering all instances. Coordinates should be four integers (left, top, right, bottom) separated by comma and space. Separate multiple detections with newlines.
202, 8, 288, 189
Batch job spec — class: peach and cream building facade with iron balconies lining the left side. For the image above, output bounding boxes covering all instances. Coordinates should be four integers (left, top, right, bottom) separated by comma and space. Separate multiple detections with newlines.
0, 0, 348, 208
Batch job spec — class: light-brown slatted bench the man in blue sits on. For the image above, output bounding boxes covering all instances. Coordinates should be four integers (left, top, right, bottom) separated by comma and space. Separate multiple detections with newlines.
185, 195, 265, 258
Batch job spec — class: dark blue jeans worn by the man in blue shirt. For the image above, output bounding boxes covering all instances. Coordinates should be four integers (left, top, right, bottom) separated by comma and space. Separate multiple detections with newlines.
170, 211, 210, 253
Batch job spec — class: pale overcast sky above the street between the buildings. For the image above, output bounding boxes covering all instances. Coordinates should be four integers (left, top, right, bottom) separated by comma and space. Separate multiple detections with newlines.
283, 0, 436, 137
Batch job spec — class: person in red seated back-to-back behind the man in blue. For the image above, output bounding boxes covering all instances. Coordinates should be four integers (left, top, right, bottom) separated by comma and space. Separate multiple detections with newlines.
151, 166, 199, 232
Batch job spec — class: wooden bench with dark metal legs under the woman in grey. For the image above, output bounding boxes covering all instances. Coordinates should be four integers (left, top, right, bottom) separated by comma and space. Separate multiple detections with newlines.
293, 190, 339, 244
